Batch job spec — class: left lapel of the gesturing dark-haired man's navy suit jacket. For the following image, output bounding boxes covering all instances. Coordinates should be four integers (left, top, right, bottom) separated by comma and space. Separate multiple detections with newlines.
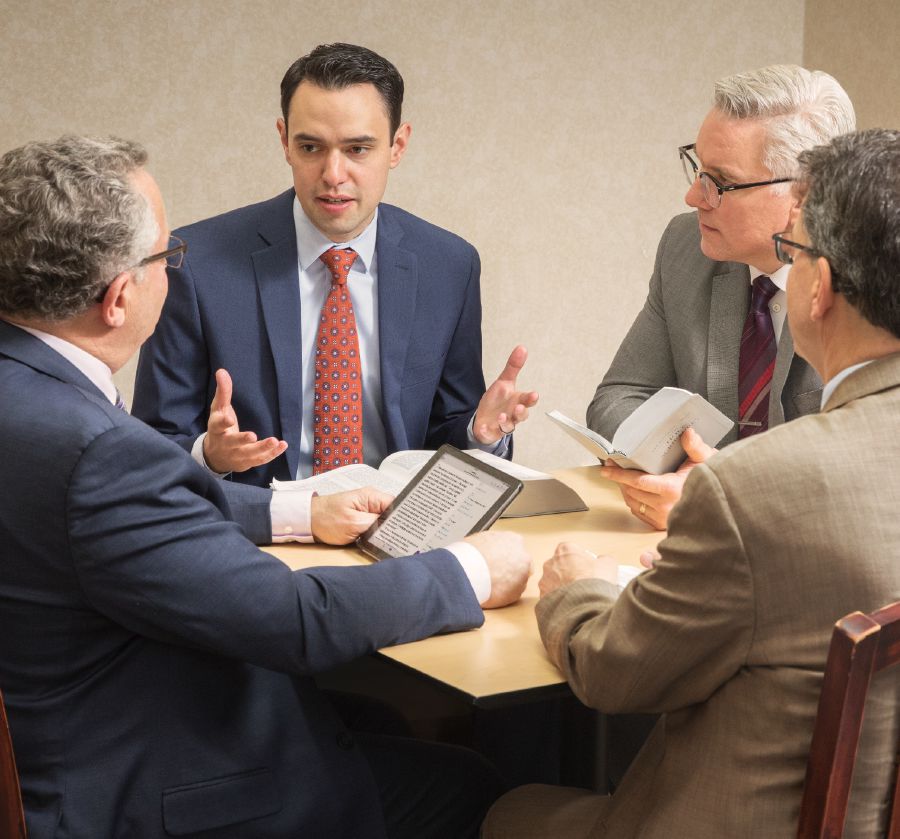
251, 189, 303, 477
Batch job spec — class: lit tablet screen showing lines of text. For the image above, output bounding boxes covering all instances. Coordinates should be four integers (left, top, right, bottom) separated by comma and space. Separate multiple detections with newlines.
360, 458, 506, 556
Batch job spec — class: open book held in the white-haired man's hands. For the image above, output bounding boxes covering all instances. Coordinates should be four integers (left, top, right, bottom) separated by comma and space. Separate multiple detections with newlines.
547, 387, 734, 475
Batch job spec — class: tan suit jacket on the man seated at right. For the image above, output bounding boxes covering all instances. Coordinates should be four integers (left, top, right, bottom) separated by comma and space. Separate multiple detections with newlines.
536, 353, 900, 839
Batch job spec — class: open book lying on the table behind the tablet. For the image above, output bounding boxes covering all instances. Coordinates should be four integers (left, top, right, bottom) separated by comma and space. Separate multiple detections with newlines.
272, 449, 587, 518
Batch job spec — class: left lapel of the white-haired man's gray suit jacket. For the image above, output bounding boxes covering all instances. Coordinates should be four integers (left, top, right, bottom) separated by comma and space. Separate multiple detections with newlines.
706, 262, 750, 442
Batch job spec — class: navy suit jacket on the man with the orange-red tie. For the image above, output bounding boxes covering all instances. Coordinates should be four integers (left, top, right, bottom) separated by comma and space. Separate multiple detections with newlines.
132, 189, 485, 486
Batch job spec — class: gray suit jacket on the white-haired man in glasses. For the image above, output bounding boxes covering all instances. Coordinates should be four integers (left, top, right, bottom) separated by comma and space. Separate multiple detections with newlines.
587, 213, 822, 445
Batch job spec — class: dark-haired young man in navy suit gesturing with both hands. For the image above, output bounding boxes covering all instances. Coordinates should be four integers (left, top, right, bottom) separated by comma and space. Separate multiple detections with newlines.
133, 44, 537, 486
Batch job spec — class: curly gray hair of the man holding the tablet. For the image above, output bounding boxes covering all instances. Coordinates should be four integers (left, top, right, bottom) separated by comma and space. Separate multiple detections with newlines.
0, 136, 159, 321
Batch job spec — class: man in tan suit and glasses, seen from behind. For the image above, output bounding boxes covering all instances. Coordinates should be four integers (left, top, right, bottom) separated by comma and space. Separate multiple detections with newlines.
483, 130, 900, 839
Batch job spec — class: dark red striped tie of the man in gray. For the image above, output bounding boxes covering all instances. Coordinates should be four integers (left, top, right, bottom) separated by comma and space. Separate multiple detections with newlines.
738, 276, 778, 438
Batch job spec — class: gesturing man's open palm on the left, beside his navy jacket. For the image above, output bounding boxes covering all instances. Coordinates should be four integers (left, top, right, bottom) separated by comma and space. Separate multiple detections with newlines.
203, 370, 287, 473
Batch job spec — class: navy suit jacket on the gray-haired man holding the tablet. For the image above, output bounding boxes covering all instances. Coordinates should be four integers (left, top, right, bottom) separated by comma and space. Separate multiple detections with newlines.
0, 321, 483, 839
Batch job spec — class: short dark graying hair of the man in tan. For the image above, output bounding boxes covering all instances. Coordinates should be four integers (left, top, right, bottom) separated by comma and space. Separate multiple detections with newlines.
798, 128, 900, 338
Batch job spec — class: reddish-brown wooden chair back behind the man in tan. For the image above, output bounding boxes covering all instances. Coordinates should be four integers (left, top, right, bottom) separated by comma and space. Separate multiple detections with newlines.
797, 603, 900, 839
